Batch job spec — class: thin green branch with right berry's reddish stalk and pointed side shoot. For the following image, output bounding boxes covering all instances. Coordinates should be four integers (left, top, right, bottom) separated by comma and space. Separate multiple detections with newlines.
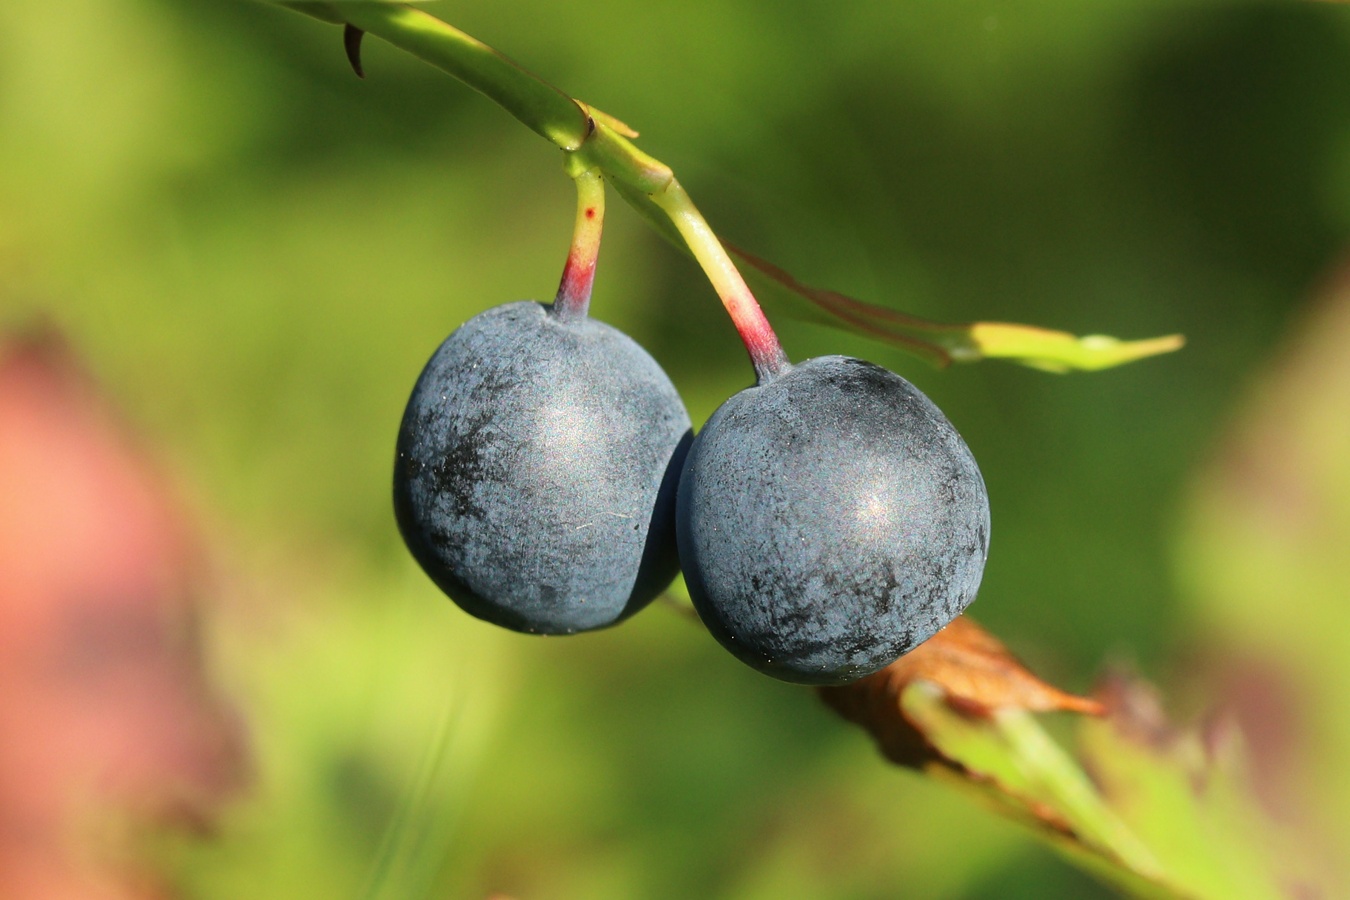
273, 0, 1183, 379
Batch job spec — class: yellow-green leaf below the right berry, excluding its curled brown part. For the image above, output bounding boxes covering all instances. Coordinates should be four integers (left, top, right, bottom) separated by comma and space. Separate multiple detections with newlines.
899, 677, 1312, 900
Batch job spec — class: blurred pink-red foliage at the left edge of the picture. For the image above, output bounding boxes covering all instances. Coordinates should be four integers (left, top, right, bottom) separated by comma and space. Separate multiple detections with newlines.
0, 329, 247, 900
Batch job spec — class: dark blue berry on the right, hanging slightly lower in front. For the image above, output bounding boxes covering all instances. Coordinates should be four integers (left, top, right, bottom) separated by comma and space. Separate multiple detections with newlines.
676, 356, 990, 684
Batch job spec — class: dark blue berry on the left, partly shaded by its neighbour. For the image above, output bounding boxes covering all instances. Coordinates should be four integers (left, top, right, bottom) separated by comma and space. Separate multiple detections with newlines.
394, 301, 691, 634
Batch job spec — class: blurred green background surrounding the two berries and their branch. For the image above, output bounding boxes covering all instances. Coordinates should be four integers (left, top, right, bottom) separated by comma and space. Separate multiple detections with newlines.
0, 0, 1350, 900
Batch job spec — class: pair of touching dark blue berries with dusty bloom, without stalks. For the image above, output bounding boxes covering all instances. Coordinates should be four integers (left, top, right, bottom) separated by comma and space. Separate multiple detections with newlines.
394, 302, 990, 684
